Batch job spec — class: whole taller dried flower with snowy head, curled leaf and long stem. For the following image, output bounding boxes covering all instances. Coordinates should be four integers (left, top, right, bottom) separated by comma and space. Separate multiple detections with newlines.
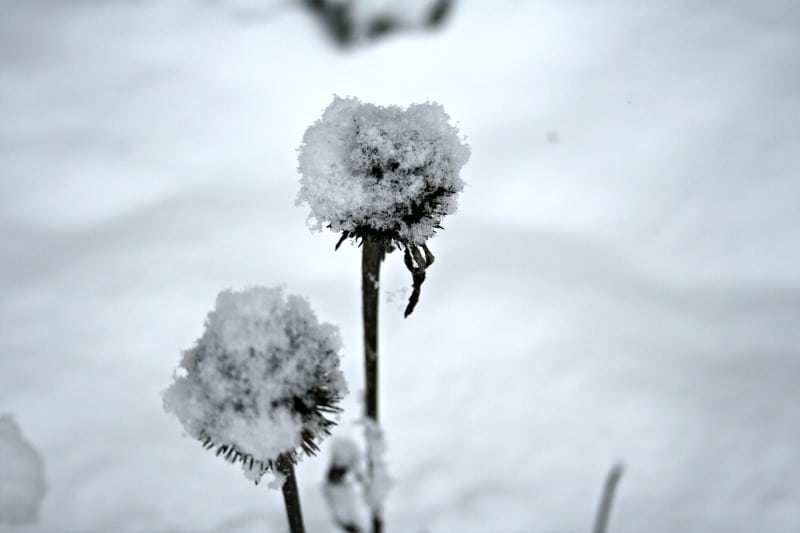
297, 97, 470, 533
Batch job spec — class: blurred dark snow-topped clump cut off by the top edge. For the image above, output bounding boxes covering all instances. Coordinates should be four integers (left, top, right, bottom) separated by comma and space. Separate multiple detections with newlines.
303, 0, 454, 47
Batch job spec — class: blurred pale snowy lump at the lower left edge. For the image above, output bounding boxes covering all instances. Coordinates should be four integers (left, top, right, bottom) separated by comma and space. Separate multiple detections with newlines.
0, 415, 47, 525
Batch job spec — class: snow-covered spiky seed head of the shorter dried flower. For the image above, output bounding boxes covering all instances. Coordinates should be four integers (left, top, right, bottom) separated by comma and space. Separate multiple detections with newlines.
164, 287, 347, 482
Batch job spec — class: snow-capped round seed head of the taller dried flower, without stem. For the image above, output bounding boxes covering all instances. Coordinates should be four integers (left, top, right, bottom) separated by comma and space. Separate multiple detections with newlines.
297, 96, 470, 245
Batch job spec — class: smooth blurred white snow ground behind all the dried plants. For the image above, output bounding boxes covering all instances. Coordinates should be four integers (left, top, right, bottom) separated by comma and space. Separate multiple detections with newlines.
0, 0, 800, 533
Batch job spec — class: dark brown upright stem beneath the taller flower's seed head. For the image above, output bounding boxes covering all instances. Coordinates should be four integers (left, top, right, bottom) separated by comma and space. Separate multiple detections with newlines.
361, 237, 386, 533
